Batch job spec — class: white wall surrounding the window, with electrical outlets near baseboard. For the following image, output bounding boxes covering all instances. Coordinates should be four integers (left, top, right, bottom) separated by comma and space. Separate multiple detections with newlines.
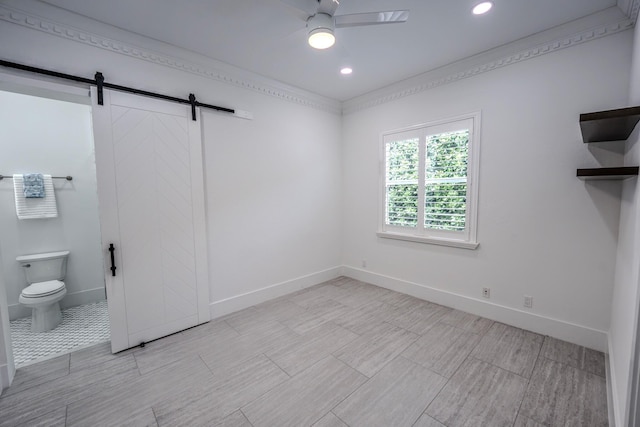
343, 31, 632, 350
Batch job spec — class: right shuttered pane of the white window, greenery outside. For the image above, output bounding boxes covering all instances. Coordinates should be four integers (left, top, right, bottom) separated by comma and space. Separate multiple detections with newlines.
424, 130, 469, 231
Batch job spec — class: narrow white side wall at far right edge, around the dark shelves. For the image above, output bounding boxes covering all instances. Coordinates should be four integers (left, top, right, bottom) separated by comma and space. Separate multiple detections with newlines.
609, 15, 640, 426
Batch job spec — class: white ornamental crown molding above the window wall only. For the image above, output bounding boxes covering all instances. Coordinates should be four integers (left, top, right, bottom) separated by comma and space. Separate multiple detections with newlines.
342, 8, 640, 115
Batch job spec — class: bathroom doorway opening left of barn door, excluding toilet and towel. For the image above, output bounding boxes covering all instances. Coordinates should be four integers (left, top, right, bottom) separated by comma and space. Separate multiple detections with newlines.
0, 85, 110, 368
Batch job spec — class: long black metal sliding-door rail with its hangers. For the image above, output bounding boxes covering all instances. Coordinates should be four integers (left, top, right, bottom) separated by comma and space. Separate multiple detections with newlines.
0, 59, 235, 121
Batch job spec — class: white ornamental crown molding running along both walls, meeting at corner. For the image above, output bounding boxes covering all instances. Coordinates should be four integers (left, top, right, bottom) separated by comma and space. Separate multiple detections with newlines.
0, 0, 640, 114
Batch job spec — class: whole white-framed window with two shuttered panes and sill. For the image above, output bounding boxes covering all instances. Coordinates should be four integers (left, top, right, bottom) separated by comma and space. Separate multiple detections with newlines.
378, 113, 480, 249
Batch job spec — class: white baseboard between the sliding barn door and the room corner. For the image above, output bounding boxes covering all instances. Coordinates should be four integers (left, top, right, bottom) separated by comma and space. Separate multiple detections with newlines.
209, 267, 342, 319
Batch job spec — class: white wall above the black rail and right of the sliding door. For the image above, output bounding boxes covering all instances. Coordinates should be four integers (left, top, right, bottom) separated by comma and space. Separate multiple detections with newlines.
0, 1, 341, 316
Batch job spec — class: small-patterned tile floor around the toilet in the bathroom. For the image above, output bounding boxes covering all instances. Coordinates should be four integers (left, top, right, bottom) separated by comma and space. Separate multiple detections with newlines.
10, 301, 110, 367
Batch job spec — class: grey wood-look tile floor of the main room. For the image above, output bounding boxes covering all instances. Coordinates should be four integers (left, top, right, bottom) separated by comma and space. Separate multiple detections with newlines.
0, 277, 608, 427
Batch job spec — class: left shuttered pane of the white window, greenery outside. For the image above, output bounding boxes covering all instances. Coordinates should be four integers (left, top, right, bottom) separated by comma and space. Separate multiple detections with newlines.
385, 138, 420, 227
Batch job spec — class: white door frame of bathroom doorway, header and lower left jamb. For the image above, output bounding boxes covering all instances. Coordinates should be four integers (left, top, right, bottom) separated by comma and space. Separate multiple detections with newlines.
0, 72, 91, 393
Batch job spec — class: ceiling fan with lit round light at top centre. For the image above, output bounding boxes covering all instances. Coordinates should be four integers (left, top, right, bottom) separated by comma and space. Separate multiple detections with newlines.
281, 0, 409, 49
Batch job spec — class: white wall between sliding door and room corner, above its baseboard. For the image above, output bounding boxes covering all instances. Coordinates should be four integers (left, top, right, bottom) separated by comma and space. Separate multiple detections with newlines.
203, 97, 342, 314
